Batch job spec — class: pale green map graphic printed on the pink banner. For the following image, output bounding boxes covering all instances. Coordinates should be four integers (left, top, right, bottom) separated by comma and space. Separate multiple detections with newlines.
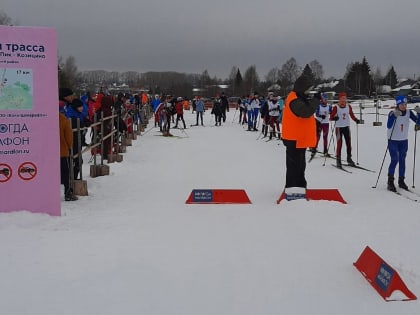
0, 68, 33, 110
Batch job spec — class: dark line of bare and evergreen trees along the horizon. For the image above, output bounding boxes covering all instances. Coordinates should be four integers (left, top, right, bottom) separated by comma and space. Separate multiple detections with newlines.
0, 10, 398, 98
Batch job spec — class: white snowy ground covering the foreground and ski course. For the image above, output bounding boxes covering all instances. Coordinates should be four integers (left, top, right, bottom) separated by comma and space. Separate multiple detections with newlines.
0, 102, 420, 315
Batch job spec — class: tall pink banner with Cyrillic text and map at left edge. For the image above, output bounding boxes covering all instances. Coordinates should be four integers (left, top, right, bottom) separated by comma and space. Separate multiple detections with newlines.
0, 26, 61, 215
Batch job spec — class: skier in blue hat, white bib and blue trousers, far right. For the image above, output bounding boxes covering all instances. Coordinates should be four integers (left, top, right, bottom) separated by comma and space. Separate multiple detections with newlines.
386, 95, 420, 192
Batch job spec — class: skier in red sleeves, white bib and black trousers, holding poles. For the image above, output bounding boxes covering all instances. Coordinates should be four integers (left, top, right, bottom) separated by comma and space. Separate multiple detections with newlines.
330, 92, 360, 168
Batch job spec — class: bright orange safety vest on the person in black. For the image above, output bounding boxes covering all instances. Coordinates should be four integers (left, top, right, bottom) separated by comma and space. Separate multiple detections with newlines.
281, 91, 316, 149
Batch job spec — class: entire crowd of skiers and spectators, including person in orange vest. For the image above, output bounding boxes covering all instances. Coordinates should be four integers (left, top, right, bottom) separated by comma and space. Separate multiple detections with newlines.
59, 82, 420, 204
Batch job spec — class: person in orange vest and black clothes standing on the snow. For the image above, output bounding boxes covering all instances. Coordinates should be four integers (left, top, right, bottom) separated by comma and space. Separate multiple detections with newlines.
282, 75, 320, 200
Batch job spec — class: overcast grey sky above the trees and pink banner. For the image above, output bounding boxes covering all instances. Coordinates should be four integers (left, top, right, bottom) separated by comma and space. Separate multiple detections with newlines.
0, 0, 420, 79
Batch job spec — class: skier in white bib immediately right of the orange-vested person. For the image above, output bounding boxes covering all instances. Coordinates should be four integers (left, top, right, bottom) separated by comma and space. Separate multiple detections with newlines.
311, 94, 332, 156
